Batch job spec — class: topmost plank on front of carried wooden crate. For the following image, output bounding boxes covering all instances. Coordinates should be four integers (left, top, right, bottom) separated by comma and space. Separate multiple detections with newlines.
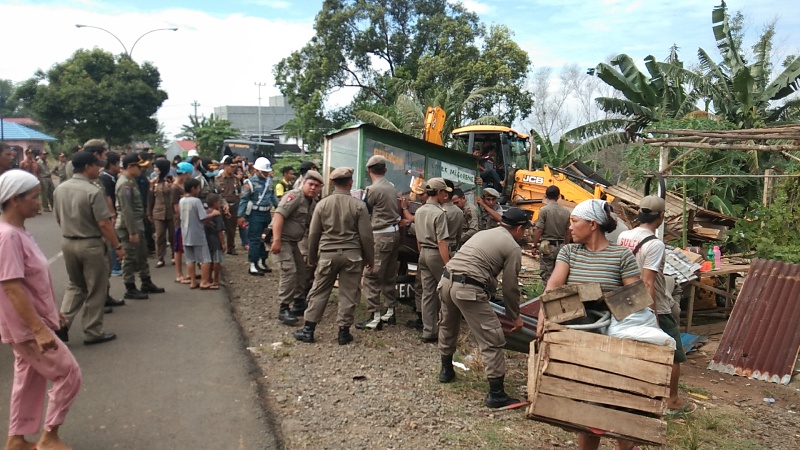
544, 330, 674, 367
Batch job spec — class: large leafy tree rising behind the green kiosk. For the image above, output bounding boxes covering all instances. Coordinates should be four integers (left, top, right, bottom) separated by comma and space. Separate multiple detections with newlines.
273, 0, 533, 148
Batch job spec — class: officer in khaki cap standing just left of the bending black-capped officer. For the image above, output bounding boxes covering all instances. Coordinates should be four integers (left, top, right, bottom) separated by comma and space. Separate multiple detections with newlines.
414, 178, 452, 343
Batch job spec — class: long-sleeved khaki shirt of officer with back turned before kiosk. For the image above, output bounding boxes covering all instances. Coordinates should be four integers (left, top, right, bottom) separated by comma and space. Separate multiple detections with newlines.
308, 190, 375, 266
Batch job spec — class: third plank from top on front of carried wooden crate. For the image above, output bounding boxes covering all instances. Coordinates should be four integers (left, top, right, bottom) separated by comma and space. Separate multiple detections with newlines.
548, 361, 669, 398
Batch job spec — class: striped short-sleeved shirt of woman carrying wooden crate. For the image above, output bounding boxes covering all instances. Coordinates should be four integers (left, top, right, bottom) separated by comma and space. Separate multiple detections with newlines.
557, 244, 641, 292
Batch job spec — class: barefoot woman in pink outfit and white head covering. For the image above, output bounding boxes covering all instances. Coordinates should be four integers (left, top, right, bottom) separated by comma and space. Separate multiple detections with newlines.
0, 170, 81, 450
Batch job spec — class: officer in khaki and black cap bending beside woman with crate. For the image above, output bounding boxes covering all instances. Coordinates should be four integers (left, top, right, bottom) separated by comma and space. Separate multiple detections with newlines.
439, 208, 531, 408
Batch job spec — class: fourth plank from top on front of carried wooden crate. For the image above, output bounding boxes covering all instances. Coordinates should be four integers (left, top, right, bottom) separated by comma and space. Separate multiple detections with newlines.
536, 375, 667, 416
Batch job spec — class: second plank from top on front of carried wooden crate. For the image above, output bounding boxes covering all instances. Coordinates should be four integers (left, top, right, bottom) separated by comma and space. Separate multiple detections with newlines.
548, 344, 672, 385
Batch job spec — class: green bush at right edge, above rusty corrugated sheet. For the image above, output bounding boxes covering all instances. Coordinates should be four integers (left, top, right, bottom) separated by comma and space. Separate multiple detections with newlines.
730, 180, 800, 263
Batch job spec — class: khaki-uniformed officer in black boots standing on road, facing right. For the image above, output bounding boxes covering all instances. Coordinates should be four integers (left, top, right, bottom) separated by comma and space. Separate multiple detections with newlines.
115, 153, 164, 300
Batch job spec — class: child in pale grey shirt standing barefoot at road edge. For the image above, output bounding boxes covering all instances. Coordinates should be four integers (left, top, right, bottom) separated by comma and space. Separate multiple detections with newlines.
180, 178, 219, 290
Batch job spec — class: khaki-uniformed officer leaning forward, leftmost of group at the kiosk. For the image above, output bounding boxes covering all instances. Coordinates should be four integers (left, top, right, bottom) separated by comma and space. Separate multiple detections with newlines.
270, 170, 325, 325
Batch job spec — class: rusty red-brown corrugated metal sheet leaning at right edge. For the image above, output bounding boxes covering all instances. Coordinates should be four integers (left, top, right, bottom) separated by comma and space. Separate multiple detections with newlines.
708, 259, 800, 384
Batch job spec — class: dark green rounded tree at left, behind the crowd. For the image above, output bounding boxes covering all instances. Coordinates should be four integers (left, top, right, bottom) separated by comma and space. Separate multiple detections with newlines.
17, 49, 167, 145
